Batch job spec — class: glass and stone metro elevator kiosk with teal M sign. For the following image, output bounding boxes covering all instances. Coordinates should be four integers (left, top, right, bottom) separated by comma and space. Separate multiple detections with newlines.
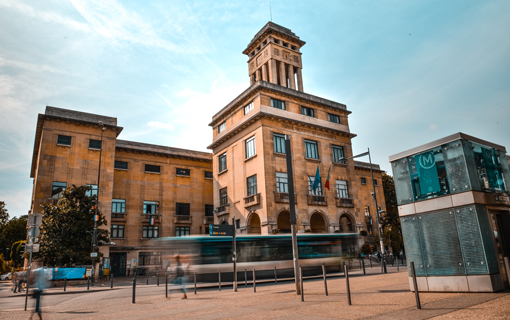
390, 133, 510, 292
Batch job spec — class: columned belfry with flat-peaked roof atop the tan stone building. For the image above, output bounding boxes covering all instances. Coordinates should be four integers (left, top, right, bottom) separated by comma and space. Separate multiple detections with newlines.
243, 22, 306, 92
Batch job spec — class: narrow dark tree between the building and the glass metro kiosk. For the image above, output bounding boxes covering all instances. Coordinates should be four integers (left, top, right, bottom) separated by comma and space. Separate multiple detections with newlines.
381, 172, 404, 253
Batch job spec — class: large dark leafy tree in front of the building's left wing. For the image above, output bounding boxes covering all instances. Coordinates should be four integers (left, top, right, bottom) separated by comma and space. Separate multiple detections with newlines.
37, 186, 109, 267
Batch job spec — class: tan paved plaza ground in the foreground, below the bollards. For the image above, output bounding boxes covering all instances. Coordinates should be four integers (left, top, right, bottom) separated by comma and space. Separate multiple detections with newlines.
0, 271, 510, 320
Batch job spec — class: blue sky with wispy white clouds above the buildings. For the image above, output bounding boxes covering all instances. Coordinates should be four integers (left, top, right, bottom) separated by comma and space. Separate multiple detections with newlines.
0, 0, 510, 216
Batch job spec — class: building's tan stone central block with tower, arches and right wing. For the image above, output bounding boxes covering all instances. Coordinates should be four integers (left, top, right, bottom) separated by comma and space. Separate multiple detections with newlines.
208, 22, 385, 241
